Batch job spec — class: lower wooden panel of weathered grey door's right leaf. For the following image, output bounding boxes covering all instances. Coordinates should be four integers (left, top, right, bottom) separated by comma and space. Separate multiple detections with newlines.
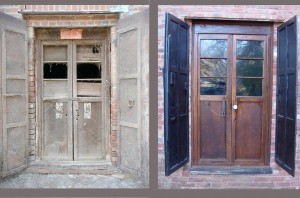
74, 101, 104, 160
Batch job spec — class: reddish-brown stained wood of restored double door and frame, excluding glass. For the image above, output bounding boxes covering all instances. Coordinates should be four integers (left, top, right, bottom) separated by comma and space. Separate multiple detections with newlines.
191, 21, 272, 167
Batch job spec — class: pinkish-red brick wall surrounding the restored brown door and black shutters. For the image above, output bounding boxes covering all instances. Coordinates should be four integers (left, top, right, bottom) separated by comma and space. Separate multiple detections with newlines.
158, 5, 300, 188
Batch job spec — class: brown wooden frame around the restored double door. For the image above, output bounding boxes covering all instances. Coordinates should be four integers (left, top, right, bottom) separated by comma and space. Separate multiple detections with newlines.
191, 20, 273, 167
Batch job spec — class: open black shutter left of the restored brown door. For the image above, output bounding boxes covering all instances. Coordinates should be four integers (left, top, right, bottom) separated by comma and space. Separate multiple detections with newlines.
164, 13, 189, 176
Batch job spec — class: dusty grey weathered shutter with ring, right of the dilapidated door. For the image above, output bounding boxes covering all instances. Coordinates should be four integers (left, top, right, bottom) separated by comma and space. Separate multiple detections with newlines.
117, 10, 149, 175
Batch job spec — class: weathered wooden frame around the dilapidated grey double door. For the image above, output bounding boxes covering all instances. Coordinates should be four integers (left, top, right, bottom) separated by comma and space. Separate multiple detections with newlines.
33, 27, 111, 161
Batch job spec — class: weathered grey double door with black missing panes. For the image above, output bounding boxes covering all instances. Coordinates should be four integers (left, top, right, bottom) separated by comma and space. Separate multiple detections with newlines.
39, 40, 105, 160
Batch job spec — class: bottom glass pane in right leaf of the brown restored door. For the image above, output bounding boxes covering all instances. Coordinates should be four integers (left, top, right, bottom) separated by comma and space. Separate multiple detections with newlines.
236, 78, 262, 96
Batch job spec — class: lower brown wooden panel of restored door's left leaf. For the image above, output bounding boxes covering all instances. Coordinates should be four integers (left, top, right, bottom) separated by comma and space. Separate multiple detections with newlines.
200, 101, 226, 161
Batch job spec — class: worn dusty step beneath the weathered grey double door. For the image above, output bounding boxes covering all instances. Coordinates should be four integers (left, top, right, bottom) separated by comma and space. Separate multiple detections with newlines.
25, 161, 124, 175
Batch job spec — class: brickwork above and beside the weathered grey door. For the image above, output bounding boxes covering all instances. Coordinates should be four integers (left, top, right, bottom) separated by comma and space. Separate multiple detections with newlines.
0, 5, 148, 165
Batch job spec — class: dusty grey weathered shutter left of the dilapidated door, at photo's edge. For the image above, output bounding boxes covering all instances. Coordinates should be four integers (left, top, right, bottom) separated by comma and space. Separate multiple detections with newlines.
0, 13, 28, 176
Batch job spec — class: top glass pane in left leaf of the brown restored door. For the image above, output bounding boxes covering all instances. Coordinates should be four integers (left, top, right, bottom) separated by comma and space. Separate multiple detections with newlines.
200, 40, 227, 58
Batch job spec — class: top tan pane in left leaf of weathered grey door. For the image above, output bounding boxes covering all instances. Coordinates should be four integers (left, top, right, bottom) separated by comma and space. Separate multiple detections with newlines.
43, 45, 68, 62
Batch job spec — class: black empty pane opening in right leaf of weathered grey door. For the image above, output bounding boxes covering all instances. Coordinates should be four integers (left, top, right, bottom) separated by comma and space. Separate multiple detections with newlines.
77, 63, 101, 79
